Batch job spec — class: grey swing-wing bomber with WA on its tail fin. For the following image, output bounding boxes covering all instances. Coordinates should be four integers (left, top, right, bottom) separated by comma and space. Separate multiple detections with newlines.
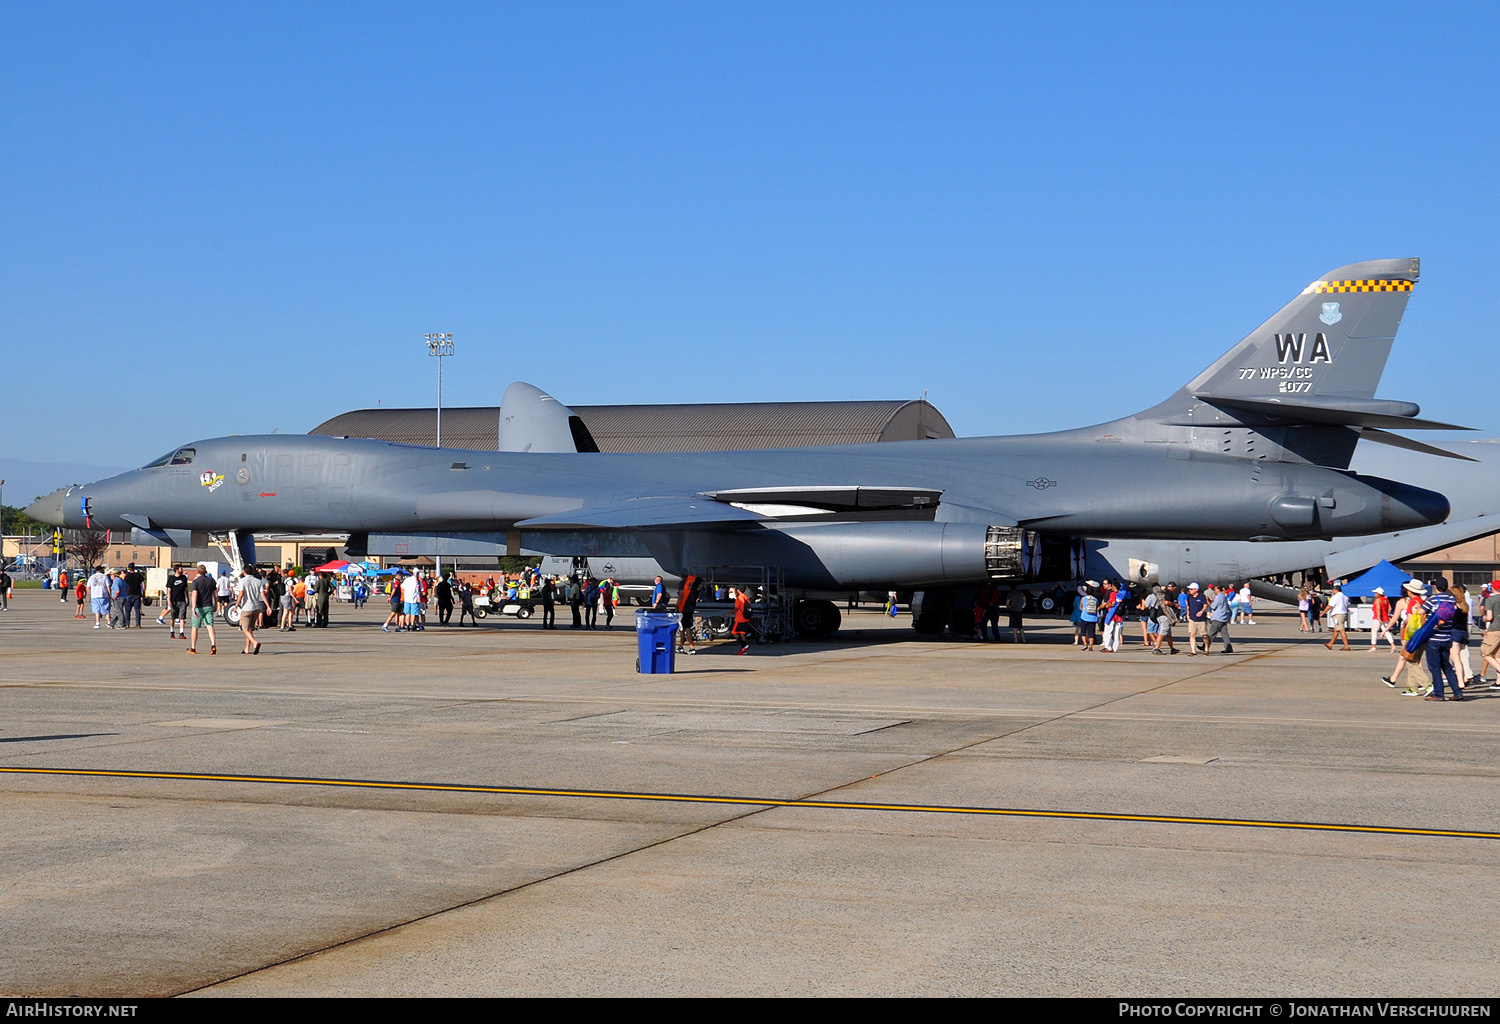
27, 259, 1452, 635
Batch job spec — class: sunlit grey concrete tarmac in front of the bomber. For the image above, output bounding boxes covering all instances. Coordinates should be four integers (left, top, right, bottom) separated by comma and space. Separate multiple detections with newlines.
0, 591, 1500, 997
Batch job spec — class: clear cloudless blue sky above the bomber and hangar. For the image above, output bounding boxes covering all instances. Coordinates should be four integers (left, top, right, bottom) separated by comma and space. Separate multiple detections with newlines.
0, 3, 1500, 504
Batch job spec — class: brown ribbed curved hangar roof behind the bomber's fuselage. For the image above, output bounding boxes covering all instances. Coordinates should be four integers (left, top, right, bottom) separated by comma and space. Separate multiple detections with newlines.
309, 399, 954, 451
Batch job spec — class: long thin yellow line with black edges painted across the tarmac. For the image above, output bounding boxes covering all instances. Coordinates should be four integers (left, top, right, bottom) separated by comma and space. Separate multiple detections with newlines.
0, 766, 1500, 840
